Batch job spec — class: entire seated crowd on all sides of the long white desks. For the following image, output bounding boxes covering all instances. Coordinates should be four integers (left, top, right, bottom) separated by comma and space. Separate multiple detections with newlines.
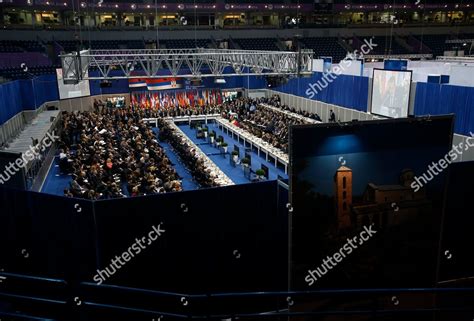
59, 95, 320, 199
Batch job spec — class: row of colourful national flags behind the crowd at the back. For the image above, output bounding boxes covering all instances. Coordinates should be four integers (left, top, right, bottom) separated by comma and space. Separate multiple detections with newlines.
131, 89, 223, 109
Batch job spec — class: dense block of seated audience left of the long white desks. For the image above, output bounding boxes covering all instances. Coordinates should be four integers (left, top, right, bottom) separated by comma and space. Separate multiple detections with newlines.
60, 109, 182, 199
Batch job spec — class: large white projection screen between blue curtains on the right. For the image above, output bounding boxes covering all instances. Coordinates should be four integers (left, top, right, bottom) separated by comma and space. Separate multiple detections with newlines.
370, 69, 412, 118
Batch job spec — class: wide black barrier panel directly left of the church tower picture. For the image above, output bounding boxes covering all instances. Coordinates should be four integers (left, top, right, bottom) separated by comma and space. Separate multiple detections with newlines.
89, 181, 287, 293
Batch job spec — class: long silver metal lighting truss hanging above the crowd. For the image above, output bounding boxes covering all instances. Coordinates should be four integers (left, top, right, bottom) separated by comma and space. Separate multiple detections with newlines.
60, 48, 313, 83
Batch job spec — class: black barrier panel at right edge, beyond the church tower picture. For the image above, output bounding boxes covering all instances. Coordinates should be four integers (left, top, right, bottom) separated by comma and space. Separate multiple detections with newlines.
440, 162, 474, 281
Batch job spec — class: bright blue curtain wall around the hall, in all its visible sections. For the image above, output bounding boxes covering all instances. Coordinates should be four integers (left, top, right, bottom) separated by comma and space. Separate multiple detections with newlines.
0, 70, 474, 135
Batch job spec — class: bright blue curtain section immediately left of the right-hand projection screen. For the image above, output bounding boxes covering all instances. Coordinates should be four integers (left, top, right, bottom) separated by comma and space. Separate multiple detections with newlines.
275, 72, 369, 112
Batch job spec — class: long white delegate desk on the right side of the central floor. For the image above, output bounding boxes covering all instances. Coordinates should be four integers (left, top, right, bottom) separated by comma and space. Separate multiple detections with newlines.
216, 117, 289, 174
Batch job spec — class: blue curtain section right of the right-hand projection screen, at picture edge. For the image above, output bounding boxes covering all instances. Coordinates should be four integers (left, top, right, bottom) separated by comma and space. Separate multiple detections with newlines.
415, 83, 474, 135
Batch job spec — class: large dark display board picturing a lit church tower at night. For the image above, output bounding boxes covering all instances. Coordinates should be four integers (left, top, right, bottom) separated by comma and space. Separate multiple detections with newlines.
290, 116, 457, 290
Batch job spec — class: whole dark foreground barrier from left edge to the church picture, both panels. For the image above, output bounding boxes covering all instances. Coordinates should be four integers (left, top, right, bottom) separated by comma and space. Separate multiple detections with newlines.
0, 181, 288, 293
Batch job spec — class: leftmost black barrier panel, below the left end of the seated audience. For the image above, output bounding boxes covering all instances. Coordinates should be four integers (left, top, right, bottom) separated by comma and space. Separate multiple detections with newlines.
0, 188, 96, 279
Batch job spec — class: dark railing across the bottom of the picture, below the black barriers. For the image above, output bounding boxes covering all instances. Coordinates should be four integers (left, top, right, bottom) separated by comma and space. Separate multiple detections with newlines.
0, 272, 474, 320
